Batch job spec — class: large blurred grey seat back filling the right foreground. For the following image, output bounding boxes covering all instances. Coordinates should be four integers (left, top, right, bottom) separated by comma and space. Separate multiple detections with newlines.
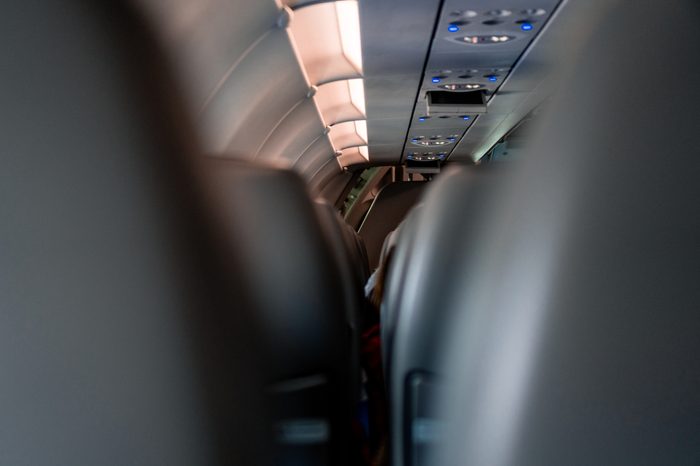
439, 0, 700, 466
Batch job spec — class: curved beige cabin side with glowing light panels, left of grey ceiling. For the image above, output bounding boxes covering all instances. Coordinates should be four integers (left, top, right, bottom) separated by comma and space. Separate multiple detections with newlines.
145, 0, 367, 193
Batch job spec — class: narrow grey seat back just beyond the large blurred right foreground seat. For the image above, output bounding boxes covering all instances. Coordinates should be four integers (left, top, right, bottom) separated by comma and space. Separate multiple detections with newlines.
382, 166, 496, 466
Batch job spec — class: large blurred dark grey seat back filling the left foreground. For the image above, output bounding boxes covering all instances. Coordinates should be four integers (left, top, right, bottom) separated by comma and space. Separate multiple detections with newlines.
0, 0, 264, 466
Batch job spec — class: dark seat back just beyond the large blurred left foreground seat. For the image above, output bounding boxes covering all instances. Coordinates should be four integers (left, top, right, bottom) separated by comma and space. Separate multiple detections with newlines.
207, 157, 361, 465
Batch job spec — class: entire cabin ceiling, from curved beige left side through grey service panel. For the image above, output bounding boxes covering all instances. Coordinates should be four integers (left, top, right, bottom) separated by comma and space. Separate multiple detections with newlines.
144, 0, 563, 186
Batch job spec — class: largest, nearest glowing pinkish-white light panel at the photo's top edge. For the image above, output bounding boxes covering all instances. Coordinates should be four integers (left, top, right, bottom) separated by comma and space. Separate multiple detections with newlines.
289, 0, 362, 86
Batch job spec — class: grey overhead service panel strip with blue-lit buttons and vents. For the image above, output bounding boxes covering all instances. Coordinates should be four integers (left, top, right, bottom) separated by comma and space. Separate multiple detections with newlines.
402, 0, 559, 162
